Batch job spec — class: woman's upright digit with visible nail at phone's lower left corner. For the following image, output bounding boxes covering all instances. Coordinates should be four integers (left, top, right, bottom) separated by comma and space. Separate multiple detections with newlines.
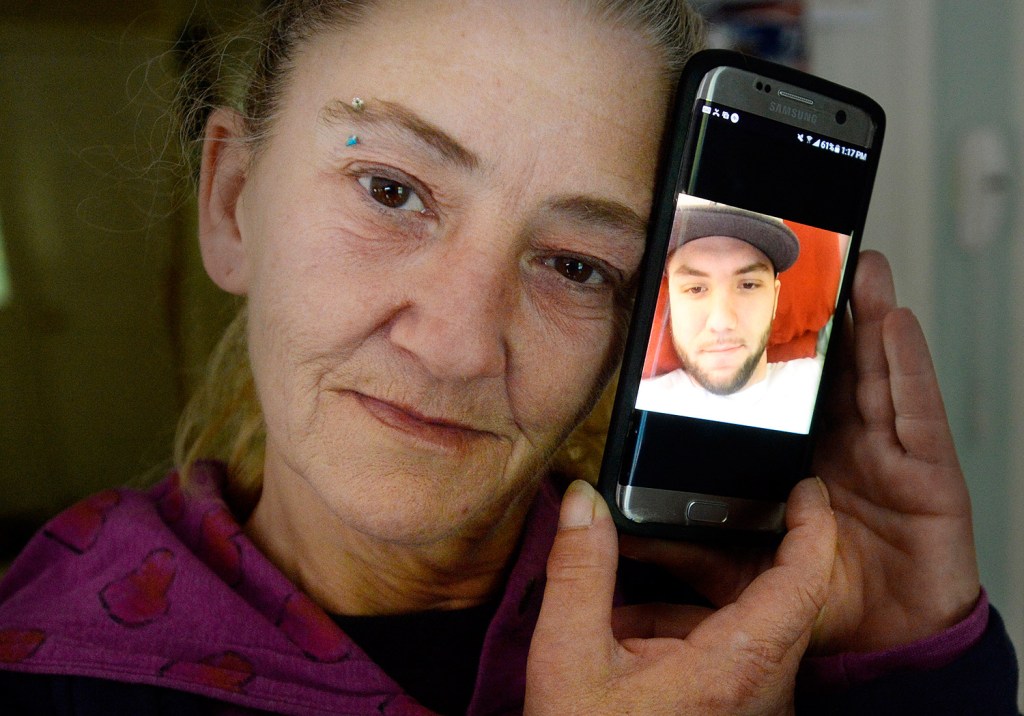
530, 480, 618, 668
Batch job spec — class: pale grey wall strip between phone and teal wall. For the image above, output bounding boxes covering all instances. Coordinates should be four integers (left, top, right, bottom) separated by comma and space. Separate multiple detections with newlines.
806, 0, 935, 333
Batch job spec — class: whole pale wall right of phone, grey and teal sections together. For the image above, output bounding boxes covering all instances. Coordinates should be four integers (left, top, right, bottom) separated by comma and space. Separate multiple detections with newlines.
807, 0, 1024, 703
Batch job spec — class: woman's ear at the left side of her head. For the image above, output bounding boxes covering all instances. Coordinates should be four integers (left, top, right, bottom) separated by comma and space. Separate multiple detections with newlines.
199, 108, 249, 295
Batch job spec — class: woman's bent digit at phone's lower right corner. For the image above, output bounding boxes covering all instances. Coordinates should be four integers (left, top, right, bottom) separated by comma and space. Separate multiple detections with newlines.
690, 479, 837, 668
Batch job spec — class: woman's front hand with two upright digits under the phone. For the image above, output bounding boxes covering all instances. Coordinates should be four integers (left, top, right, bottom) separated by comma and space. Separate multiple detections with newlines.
525, 479, 836, 716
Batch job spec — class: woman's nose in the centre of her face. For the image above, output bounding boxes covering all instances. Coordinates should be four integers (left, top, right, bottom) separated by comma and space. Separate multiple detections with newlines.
390, 235, 509, 380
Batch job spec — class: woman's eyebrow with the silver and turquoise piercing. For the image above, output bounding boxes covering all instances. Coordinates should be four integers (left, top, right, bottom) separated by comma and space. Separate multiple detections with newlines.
319, 99, 480, 169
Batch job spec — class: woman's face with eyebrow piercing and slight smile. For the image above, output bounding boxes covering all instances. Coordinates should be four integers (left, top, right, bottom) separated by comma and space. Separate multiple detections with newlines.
218, 0, 666, 542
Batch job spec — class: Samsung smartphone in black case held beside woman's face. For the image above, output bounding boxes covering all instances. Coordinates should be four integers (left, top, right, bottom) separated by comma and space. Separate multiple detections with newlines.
600, 50, 885, 539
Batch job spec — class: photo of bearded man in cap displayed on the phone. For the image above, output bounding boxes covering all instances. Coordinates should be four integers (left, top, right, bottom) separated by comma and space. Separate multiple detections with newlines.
636, 194, 850, 434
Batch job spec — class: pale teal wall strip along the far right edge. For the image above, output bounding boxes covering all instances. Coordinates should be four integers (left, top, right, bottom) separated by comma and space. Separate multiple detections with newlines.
935, 0, 1024, 709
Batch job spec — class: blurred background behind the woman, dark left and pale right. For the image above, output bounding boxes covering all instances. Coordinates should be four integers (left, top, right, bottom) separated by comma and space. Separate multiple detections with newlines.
0, 0, 1024, 704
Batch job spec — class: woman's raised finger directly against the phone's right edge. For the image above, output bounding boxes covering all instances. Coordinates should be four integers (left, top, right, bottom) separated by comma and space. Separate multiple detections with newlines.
851, 251, 896, 431
